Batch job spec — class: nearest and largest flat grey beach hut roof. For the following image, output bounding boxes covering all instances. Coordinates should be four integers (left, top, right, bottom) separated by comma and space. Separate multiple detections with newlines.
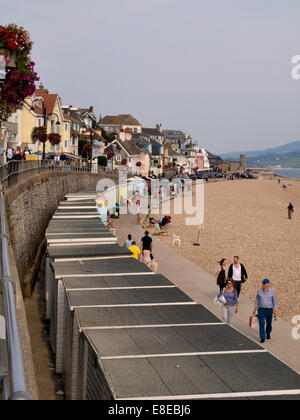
95, 353, 300, 399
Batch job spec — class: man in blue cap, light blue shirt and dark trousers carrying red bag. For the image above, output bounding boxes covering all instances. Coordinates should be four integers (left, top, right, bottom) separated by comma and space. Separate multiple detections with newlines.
253, 279, 278, 344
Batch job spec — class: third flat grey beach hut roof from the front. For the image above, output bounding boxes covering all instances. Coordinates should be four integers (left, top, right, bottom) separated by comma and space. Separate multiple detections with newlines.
75, 304, 221, 328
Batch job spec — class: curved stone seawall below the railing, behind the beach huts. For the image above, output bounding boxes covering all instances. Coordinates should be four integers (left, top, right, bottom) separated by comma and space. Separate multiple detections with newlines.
5, 172, 117, 292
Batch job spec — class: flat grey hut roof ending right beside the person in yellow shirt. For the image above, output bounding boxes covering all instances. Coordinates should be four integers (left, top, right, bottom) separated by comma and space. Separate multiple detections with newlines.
47, 244, 132, 259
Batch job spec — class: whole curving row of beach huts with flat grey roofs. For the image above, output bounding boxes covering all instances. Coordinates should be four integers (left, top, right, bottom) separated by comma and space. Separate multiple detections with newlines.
46, 189, 300, 400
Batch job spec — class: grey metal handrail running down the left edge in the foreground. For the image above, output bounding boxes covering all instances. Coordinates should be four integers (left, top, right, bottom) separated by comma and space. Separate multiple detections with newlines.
0, 186, 33, 401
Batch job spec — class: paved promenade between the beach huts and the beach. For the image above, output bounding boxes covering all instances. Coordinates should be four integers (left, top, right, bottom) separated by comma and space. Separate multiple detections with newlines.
114, 216, 300, 374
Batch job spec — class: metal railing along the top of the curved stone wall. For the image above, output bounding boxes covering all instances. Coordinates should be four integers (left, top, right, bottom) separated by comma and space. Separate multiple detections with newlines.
0, 159, 98, 191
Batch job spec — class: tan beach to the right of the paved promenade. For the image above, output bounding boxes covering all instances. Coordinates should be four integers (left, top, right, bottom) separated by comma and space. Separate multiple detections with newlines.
155, 179, 300, 322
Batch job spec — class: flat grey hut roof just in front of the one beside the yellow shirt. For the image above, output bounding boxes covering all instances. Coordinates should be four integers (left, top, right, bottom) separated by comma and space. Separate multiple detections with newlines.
53, 258, 153, 278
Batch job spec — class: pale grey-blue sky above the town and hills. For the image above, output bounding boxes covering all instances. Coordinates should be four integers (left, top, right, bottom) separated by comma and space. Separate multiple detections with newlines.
0, 0, 300, 154
